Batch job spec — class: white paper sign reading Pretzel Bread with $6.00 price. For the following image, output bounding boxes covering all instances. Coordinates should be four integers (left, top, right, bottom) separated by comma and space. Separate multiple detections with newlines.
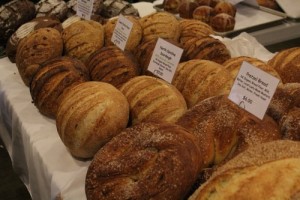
228, 62, 279, 119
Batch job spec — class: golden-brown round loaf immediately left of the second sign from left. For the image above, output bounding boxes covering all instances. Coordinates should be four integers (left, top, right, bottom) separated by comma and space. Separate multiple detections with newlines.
62, 20, 104, 63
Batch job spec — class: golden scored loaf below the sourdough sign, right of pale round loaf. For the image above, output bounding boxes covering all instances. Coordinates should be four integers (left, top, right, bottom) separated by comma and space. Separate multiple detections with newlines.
120, 76, 187, 125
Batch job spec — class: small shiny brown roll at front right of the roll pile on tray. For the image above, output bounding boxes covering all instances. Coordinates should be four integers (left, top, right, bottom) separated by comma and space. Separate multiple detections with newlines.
210, 13, 235, 32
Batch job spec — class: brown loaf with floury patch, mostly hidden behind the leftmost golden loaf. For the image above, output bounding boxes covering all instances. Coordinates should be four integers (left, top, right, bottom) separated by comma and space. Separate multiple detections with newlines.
5, 17, 62, 63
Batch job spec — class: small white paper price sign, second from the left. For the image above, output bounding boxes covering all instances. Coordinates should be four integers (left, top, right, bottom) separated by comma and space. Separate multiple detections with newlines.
111, 15, 133, 51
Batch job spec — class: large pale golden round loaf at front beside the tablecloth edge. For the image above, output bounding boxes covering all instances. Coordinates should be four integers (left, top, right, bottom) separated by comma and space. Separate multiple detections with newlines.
56, 81, 129, 159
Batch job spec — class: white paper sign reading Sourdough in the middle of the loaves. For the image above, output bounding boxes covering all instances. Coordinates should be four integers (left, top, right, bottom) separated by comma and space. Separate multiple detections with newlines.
148, 38, 183, 83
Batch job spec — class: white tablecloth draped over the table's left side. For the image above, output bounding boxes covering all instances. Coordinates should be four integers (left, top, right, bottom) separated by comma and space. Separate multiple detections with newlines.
0, 58, 90, 200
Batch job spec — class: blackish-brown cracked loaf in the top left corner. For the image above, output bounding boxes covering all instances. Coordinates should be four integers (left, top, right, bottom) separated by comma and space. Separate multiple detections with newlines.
0, 0, 35, 45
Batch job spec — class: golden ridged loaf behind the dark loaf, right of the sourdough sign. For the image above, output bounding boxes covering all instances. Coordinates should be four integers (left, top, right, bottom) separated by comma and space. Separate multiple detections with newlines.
179, 19, 214, 44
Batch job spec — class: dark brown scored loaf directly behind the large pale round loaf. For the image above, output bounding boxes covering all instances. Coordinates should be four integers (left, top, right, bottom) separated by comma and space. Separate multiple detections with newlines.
30, 57, 89, 118
